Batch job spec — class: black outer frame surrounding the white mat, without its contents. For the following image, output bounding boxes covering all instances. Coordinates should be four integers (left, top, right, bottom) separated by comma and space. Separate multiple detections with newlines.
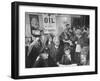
11, 2, 98, 79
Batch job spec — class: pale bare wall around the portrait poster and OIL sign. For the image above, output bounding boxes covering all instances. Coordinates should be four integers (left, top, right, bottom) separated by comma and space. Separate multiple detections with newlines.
25, 13, 71, 37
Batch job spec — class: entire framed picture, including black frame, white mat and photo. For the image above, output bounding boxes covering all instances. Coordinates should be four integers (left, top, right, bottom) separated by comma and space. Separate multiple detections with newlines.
11, 2, 97, 79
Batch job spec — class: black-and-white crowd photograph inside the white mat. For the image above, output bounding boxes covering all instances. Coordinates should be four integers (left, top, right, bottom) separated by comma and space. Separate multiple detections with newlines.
25, 12, 90, 68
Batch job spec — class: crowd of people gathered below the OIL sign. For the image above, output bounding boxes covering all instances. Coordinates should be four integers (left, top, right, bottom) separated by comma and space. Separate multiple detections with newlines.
26, 15, 89, 68
